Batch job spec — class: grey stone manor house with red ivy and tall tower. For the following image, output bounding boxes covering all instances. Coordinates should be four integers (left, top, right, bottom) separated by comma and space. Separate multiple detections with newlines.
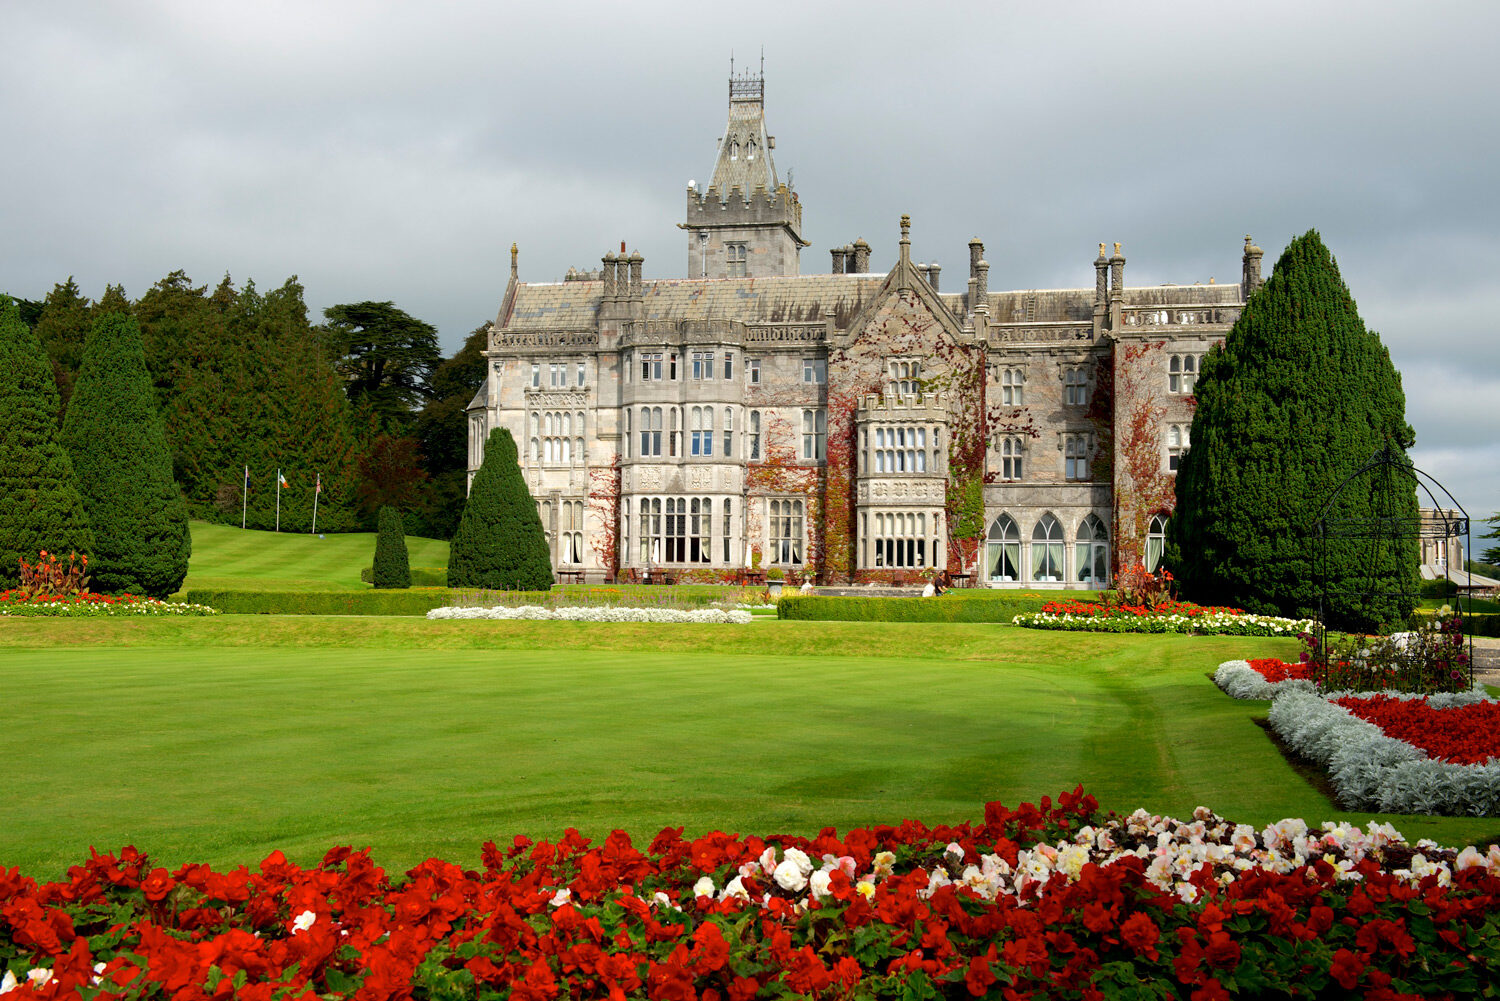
468, 75, 1262, 590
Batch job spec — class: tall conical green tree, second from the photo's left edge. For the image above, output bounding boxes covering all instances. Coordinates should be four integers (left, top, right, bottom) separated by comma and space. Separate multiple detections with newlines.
63, 312, 192, 597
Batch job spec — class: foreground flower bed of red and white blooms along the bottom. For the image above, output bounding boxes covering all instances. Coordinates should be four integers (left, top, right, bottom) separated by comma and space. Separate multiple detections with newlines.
0, 791, 1500, 1001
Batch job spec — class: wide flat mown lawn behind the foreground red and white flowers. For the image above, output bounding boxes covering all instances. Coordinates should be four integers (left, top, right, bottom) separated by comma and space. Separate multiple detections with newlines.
0, 615, 1500, 876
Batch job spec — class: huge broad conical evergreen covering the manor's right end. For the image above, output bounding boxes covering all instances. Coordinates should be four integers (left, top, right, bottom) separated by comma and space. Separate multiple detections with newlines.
1169, 231, 1418, 629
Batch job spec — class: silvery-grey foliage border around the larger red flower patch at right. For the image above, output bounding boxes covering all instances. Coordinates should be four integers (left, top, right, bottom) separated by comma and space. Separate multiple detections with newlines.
1266, 693, 1500, 816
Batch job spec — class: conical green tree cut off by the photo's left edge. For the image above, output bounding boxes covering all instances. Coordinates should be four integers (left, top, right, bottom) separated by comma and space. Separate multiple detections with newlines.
0, 296, 93, 590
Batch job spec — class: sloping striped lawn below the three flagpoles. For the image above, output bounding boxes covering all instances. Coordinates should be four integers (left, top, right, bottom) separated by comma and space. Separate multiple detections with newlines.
183, 521, 449, 591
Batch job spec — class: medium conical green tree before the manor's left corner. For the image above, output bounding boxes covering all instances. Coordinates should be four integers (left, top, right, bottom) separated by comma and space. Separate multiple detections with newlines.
449, 428, 552, 591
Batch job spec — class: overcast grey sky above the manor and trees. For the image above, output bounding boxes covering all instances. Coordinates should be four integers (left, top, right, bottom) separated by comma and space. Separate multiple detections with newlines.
0, 0, 1500, 516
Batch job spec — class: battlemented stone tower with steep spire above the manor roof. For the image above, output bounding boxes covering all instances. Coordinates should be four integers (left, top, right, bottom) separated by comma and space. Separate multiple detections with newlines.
680, 69, 807, 278
